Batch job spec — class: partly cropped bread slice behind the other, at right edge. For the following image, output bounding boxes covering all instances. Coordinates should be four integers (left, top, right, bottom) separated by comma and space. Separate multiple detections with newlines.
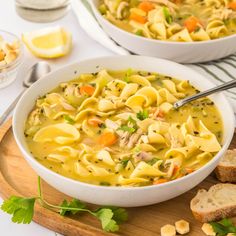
215, 149, 236, 183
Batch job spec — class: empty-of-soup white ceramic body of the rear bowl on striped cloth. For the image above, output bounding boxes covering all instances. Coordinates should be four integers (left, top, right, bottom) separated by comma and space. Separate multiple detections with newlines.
89, 0, 236, 63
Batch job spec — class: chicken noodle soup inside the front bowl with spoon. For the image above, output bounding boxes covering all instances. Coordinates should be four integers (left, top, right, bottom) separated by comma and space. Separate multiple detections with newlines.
25, 69, 223, 186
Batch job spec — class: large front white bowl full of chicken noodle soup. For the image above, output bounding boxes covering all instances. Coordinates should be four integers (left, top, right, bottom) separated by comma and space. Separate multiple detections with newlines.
13, 56, 234, 207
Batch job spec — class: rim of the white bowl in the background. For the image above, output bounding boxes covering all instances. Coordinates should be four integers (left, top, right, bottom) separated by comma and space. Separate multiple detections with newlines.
92, 0, 236, 46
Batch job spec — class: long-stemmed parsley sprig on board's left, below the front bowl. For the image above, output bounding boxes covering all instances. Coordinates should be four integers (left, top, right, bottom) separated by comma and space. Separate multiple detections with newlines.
1, 177, 128, 232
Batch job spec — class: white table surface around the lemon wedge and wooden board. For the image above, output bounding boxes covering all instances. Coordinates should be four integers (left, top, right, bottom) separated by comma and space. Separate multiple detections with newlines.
0, 0, 113, 236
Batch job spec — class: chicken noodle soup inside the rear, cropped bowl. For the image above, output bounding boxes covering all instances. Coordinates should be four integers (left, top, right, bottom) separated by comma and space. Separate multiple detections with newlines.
99, 0, 236, 42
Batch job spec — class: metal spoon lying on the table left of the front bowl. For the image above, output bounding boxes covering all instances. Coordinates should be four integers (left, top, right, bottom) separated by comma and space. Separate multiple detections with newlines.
0, 61, 51, 125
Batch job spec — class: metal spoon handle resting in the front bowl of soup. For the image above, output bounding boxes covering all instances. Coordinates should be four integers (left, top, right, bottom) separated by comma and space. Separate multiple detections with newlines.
173, 80, 236, 109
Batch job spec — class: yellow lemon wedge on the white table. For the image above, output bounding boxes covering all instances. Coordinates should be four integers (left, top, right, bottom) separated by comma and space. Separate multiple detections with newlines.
22, 26, 72, 58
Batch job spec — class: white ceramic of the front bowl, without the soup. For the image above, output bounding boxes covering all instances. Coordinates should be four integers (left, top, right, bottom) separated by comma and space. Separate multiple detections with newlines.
13, 56, 234, 207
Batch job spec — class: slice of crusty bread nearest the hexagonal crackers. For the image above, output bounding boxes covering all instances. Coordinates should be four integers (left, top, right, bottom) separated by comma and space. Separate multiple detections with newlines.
190, 184, 236, 222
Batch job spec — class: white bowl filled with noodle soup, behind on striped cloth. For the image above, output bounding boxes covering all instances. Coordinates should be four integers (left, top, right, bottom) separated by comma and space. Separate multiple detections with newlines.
87, 0, 236, 63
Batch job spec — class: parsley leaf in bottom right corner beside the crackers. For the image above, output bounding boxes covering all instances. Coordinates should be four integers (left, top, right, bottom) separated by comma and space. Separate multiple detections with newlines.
210, 218, 236, 236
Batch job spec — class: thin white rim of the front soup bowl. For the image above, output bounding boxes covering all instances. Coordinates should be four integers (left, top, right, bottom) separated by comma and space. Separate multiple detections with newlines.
12, 55, 235, 191
